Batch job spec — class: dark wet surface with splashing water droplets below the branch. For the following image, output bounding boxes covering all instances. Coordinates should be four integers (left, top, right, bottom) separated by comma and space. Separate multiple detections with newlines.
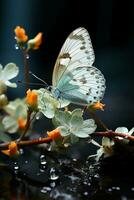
0, 145, 134, 200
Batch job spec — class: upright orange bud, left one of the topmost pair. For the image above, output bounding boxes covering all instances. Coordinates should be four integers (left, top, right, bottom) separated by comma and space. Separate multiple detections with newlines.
14, 26, 28, 42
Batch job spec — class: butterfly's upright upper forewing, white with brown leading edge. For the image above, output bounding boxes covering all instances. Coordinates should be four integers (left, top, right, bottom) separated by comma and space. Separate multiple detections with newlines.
52, 27, 95, 86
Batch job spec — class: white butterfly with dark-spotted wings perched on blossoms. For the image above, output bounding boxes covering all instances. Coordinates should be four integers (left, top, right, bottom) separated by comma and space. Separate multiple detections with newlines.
49, 27, 106, 106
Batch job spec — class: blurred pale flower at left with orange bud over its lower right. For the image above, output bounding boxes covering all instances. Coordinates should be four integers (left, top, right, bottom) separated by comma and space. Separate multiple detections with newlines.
2, 99, 27, 133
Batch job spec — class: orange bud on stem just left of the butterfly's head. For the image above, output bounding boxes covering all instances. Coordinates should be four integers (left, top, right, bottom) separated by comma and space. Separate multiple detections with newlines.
26, 89, 38, 106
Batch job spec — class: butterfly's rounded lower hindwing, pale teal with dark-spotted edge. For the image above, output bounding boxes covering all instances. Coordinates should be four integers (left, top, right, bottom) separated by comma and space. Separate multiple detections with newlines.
57, 65, 105, 105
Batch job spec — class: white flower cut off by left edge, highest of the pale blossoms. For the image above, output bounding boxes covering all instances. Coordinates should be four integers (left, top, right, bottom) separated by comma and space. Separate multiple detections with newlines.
0, 63, 19, 91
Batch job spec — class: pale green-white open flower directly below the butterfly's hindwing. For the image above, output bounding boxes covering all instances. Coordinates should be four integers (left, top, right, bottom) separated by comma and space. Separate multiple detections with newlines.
54, 109, 96, 142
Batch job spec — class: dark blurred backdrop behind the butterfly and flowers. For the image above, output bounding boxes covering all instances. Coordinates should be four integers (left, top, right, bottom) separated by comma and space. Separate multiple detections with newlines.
0, 0, 134, 129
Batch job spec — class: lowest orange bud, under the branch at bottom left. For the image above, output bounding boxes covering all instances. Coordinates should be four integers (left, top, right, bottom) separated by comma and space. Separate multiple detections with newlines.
2, 142, 19, 156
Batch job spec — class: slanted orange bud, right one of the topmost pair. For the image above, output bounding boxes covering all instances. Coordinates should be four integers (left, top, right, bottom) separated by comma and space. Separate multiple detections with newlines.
28, 33, 42, 50
